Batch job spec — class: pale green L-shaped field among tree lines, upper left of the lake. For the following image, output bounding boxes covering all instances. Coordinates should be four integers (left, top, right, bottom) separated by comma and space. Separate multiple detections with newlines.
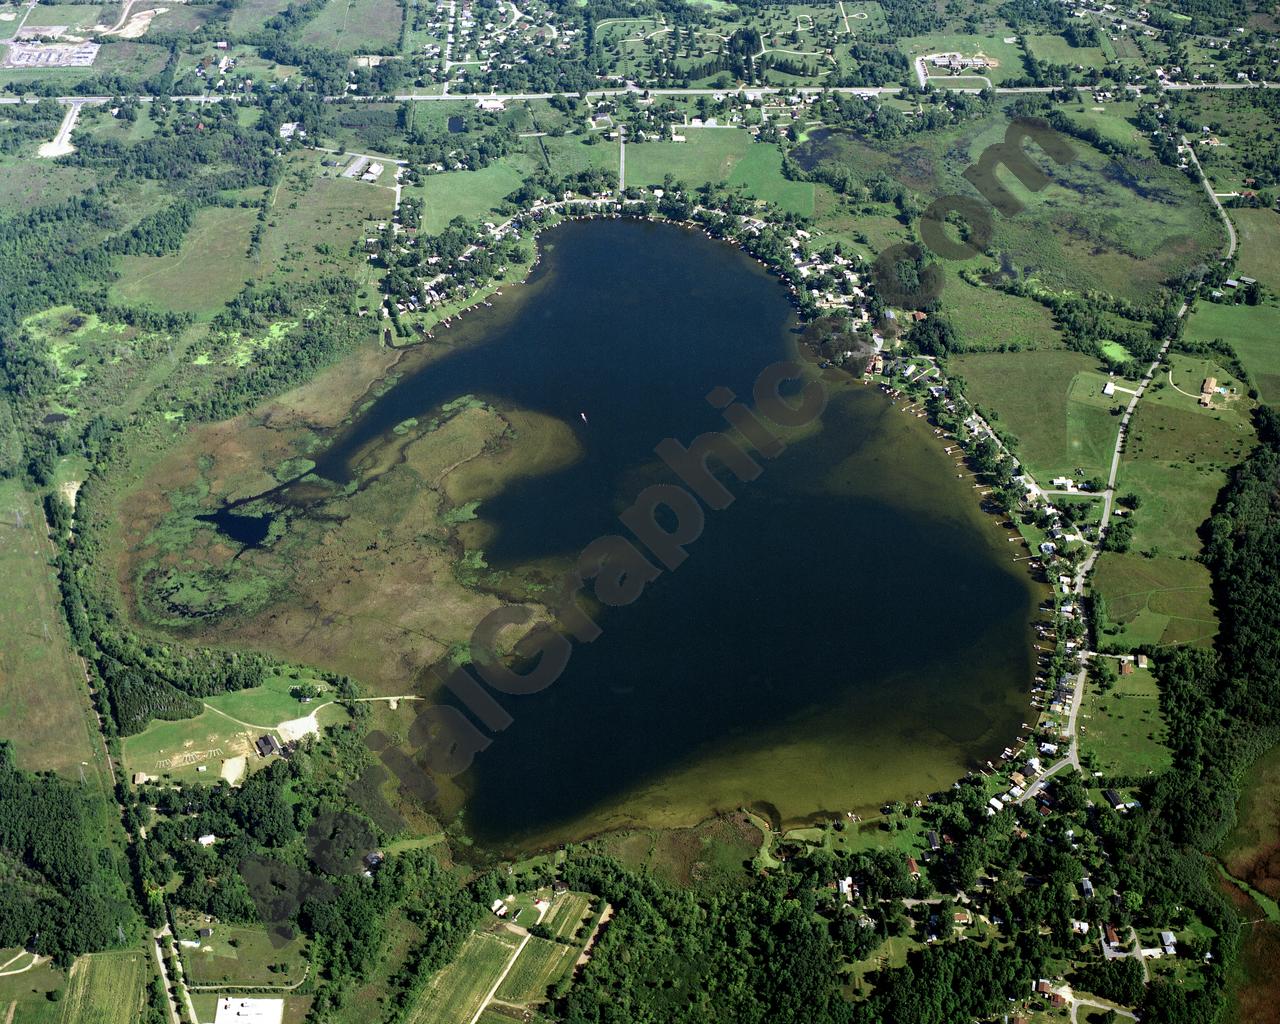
113, 206, 257, 317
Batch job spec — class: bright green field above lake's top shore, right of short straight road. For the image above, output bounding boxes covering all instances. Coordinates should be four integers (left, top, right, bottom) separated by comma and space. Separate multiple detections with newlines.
626, 125, 813, 216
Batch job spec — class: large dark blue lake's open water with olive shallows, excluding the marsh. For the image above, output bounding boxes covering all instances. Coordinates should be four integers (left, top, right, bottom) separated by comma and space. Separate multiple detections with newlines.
207, 220, 1042, 850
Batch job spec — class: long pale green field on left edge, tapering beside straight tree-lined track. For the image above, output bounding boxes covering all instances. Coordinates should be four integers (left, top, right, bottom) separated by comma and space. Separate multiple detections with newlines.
0, 480, 110, 791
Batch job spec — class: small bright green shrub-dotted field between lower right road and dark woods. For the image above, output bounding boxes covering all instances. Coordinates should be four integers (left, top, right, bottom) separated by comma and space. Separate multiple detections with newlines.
1080, 668, 1172, 776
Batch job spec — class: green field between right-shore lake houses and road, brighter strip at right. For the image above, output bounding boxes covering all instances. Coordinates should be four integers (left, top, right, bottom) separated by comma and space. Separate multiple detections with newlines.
950, 351, 1124, 484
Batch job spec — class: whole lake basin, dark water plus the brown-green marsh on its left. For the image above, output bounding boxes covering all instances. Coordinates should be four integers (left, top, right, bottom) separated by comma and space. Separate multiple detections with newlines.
118, 221, 1043, 850
